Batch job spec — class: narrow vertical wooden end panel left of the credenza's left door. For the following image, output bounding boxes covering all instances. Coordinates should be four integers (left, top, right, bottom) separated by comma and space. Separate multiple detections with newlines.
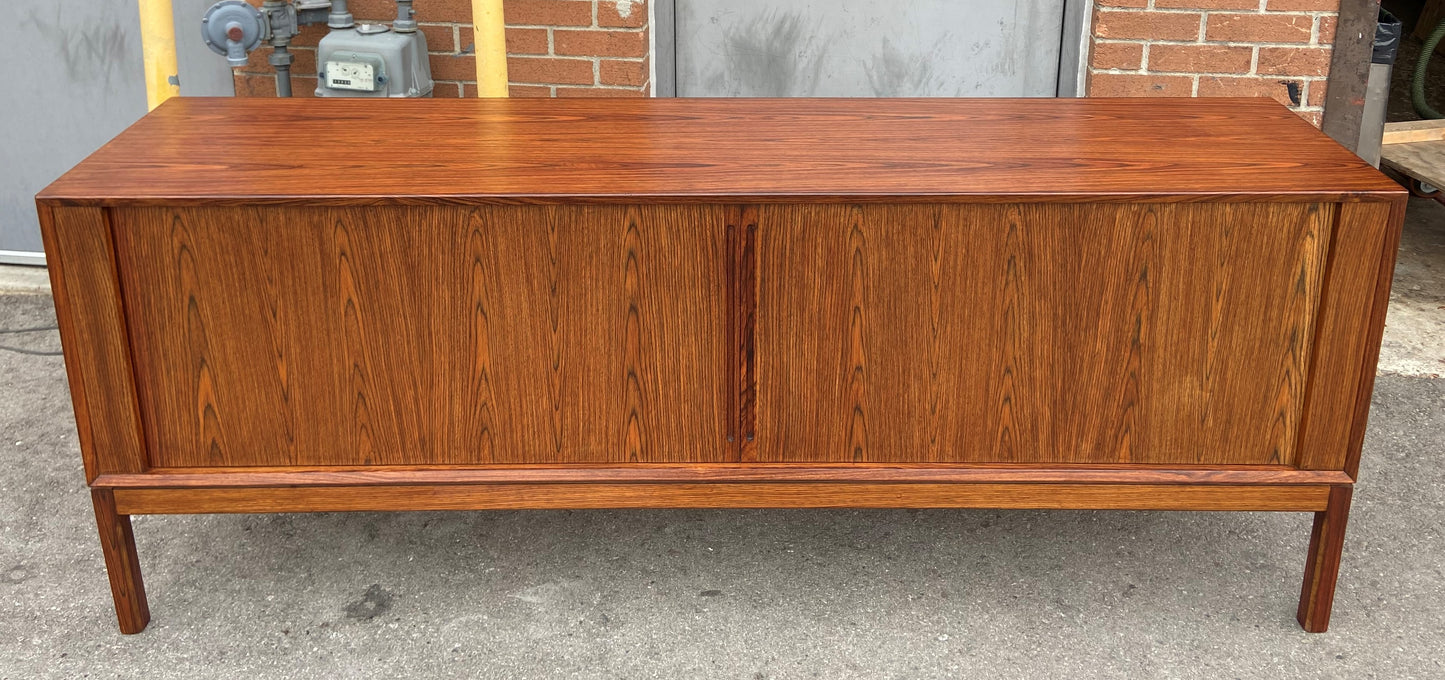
39, 206, 146, 481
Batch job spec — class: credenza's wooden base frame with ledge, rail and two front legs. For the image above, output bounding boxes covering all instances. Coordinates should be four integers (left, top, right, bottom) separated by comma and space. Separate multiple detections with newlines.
92, 466, 1351, 634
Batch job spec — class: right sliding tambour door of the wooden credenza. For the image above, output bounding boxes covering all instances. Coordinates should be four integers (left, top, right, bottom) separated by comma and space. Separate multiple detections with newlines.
756, 204, 1337, 465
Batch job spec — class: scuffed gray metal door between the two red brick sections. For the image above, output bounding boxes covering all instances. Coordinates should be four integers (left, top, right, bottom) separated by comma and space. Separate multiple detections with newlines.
670, 0, 1074, 97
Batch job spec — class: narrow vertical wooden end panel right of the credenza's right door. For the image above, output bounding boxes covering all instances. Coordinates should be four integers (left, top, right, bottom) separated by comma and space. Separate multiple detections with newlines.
1298, 198, 1405, 476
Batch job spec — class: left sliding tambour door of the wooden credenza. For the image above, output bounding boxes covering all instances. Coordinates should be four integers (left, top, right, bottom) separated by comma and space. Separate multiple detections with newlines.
116, 205, 736, 468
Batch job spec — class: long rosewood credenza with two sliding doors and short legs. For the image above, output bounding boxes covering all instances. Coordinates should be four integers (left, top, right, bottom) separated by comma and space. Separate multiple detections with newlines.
38, 100, 1406, 632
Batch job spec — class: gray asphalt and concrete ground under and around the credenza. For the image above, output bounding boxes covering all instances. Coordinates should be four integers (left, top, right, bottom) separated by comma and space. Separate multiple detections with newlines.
0, 201, 1445, 679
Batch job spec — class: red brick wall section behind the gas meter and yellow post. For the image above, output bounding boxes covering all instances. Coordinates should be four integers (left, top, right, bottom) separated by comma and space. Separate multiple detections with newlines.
234, 0, 652, 97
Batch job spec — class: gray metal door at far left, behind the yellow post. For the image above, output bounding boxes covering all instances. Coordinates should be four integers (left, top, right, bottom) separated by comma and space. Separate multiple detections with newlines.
0, 0, 233, 264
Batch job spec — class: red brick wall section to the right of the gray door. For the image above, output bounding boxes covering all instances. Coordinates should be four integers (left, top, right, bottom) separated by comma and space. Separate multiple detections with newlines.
1088, 0, 1340, 126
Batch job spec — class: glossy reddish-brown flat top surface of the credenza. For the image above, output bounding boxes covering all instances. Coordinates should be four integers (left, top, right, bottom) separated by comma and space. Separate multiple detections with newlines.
39, 98, 1402, 205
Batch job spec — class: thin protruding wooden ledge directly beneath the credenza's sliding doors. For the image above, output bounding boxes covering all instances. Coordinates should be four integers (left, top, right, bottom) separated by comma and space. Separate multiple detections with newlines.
94, 463, 1350, 495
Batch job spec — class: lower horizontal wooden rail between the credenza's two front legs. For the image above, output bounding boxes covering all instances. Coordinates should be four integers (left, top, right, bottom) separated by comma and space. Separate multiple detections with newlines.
114, 482, 1329, 514
